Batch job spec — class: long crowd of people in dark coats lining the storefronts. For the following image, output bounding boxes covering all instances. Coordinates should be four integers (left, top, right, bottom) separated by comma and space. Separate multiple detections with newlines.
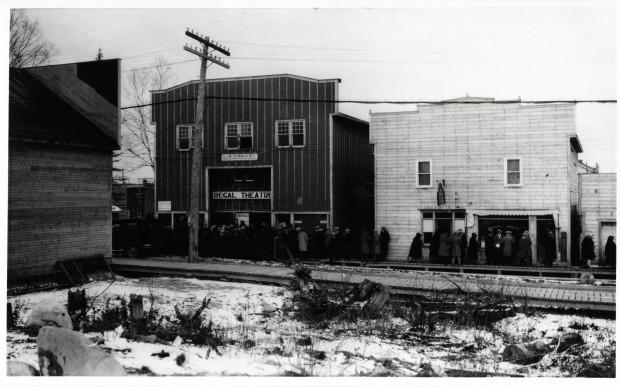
147, 221, 616, 268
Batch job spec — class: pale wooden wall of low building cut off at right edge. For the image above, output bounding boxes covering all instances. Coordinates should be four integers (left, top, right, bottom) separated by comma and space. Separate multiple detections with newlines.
579, 173, 617, 258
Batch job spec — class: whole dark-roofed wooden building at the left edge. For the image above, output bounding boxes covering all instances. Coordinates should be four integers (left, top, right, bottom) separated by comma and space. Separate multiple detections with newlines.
8, 60, 120, 280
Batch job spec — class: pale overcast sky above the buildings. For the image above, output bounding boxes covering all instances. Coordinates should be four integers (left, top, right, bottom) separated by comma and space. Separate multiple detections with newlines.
7, 2, 617, 178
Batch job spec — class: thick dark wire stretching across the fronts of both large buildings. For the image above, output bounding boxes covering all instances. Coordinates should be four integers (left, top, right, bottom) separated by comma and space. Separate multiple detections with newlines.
121, 96, 617, 110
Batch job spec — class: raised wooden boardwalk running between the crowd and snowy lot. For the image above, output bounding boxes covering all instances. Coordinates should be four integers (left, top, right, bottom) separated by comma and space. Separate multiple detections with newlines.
111, 259, 616, 311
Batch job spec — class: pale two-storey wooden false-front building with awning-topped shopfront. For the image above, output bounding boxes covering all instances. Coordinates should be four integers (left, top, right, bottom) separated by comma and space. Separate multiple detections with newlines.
370, 98, 582, 265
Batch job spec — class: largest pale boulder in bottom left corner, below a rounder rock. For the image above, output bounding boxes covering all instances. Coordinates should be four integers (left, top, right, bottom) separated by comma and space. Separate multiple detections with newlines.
37, 326, 127, 376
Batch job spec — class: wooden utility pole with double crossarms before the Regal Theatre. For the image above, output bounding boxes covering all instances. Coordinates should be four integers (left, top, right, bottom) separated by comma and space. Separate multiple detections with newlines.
183, 28, 230, 263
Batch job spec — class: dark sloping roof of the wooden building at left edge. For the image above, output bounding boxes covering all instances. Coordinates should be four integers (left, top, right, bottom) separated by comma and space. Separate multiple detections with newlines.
9, 60, 120, 149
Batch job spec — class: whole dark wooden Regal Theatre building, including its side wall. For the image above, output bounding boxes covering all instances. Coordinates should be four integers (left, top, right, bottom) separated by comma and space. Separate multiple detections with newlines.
152, 75, 374, 232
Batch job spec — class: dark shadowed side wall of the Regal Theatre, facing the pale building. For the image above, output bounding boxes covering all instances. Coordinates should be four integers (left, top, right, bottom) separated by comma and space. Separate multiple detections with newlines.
332, 115, 374, 232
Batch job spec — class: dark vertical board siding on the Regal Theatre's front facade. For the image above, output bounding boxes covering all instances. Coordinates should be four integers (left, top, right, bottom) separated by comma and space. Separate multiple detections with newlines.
152, 75, 338, 212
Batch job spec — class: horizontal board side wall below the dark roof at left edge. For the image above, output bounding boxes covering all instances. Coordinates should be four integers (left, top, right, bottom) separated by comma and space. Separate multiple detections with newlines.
8, 142, 112, 278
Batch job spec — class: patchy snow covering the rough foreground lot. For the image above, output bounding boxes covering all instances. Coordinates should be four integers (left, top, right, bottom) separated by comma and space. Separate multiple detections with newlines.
7, 277, 615, 376
